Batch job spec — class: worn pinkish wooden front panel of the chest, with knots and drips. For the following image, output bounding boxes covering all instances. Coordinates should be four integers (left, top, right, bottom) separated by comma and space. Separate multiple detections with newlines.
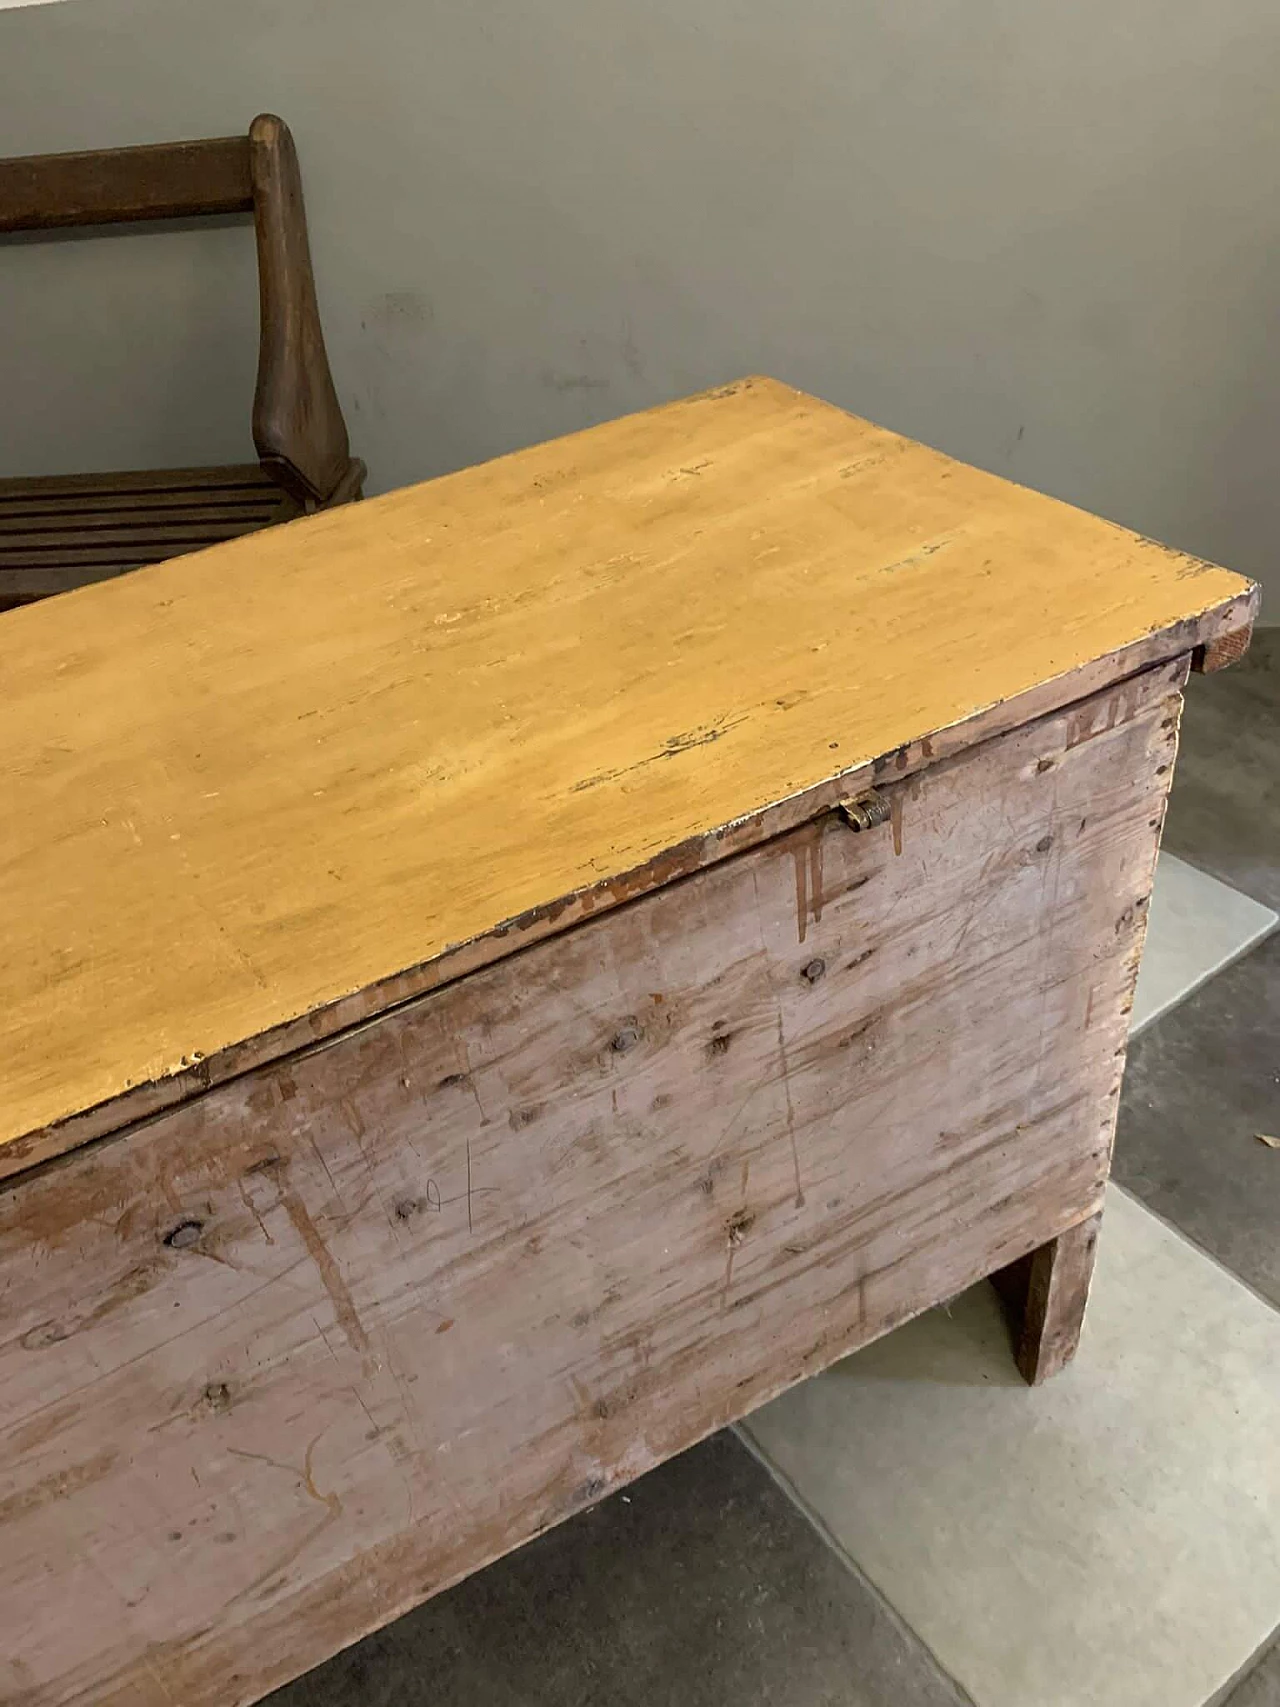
0, 666, 1183, 1707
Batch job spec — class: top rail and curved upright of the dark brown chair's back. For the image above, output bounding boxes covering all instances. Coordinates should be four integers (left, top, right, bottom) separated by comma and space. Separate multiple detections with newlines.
0, 113, 362, 507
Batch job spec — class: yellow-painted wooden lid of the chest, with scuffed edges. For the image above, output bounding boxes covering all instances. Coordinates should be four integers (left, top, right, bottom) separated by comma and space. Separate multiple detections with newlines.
0, 379, 1253, 1144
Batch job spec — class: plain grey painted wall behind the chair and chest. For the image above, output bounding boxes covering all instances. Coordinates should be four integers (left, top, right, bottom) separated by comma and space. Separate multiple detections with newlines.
0, 0, 1280, 615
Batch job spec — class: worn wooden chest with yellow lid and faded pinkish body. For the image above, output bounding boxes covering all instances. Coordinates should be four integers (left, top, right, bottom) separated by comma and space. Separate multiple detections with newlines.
0, 379, 1254, 1707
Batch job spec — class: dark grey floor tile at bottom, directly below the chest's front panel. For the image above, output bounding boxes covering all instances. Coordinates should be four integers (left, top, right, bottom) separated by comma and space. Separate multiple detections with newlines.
270, 1434, 968, 1707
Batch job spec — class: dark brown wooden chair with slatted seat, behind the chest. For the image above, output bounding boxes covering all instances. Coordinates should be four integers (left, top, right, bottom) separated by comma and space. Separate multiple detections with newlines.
0, 114, 365, 609
